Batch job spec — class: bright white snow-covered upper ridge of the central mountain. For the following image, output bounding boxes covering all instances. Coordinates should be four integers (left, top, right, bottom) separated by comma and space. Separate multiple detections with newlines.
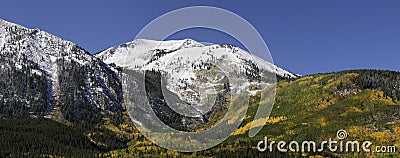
96, 39, 298, 78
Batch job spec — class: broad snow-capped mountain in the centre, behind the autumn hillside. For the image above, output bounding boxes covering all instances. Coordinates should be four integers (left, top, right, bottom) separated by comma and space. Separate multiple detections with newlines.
95, 39, 298, 128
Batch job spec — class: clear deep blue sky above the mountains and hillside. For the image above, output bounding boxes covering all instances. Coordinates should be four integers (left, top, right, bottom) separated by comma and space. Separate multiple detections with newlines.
0, 0, 400, 75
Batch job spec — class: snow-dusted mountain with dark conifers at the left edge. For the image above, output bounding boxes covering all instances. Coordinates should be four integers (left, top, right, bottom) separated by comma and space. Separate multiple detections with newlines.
0, 20, 123, 123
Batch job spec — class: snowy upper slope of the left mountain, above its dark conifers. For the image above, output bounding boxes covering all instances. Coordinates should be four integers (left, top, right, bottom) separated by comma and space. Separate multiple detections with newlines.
0, 20, 94, 74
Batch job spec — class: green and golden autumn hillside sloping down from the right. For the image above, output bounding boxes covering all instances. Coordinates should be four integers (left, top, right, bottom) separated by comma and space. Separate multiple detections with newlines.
109, 70, 400, 157
